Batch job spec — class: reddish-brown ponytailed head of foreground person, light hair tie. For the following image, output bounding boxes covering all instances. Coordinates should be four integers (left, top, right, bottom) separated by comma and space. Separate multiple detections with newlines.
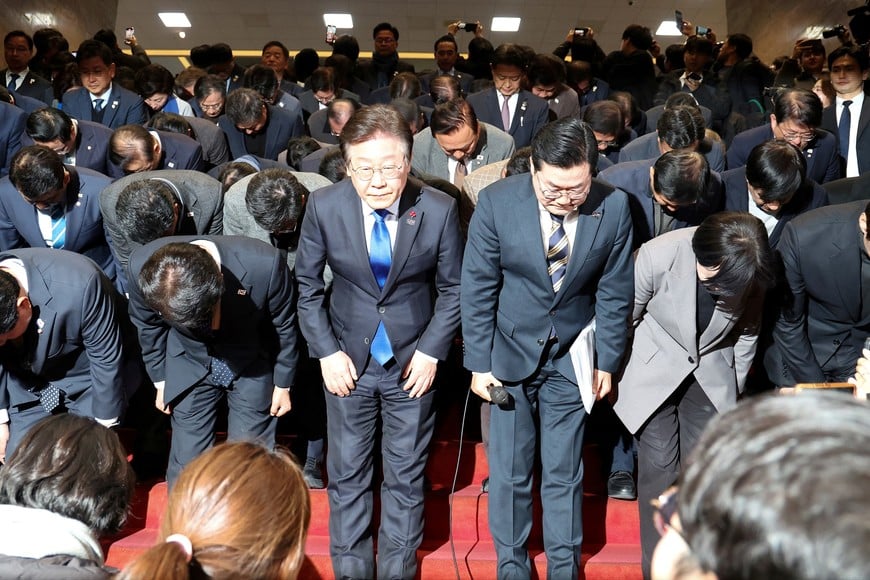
117, 442, 311, 580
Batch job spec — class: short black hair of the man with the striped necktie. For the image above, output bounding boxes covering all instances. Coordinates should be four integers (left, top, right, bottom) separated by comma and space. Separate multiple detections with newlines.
532, 117, 598, 174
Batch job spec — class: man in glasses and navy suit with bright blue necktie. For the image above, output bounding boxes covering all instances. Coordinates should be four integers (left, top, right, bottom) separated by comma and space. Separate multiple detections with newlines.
296, 105, 462, 578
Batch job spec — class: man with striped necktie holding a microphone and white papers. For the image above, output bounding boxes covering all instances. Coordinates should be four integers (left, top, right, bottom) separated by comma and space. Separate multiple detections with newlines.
460, 117, 634, 578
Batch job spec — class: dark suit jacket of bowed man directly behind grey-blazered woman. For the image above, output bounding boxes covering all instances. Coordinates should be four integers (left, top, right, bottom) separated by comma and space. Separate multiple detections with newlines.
598, 159, 725, 248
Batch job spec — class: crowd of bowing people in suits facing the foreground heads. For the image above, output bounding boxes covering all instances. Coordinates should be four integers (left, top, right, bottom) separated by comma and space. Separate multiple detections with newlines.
0, 17, 870, 578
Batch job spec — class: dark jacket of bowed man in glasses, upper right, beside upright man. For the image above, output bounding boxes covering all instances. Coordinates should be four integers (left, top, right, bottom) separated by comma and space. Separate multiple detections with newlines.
726, 124, 840, 183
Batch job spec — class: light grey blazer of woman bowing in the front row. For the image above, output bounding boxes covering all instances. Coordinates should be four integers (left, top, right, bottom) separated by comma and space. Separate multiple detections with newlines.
613, 228, 763, 433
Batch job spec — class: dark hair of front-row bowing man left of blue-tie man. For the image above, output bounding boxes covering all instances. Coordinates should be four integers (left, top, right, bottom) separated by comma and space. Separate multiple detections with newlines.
139, 242, 224, 334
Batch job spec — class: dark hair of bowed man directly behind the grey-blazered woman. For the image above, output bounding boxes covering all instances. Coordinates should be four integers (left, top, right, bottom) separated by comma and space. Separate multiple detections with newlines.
653, 151, 711, 206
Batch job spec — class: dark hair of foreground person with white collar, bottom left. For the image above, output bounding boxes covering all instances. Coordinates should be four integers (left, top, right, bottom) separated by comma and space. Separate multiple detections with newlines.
0, 413, 136, 535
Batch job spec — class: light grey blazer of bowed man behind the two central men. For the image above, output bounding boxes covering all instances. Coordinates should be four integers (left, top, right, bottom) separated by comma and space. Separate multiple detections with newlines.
411, 122, 514, 180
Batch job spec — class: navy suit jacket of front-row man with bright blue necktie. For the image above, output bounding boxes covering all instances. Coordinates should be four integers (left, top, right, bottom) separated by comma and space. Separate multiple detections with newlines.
296, 178, 462, 372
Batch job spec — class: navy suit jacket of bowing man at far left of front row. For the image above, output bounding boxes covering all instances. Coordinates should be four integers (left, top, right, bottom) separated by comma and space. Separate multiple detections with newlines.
0, 247, 137, 419
